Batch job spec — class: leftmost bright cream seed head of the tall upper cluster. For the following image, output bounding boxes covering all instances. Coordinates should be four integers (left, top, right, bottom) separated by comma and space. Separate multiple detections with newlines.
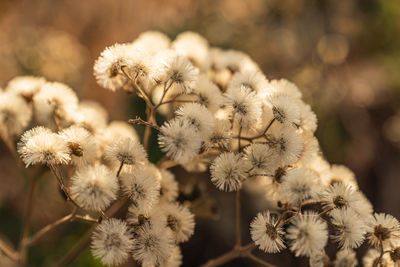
93, 44, 132, 91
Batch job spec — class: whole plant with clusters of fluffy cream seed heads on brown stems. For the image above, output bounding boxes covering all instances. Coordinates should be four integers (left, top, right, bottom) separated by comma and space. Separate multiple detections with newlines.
0, 32, 400, 267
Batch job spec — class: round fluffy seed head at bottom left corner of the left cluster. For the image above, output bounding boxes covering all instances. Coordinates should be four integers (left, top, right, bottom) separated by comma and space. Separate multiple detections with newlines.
91, 218, 133, 266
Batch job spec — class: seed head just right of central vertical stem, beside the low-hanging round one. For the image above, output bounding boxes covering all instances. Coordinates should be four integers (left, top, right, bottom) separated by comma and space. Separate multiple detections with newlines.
244, 143, 279, 175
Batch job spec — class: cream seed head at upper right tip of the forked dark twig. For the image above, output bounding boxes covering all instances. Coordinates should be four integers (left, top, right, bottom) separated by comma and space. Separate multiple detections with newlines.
269, 95, 300, 126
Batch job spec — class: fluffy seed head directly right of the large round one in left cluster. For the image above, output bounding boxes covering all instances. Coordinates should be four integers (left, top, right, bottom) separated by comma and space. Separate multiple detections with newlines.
120, 169, 160, 212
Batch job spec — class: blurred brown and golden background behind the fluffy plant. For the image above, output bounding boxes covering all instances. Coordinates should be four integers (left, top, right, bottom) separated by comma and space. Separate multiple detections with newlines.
0, 0, 400, 266
